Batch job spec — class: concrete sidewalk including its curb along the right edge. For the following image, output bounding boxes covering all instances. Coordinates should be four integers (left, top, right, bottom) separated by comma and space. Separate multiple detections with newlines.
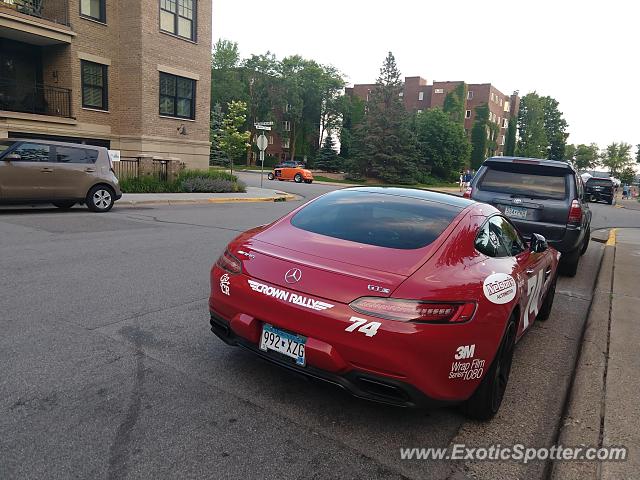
552, 228, 640, 480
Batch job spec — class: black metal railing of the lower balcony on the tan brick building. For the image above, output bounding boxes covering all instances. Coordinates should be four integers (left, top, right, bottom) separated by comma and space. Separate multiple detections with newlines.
0, 77, 71, 118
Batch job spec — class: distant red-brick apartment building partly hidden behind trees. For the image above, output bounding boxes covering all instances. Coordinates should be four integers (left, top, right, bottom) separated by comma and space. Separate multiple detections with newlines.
346, 77, 520, 155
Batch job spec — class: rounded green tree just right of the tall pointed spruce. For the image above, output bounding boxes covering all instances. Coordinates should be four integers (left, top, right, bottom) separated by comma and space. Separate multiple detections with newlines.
416, 108, 471, 180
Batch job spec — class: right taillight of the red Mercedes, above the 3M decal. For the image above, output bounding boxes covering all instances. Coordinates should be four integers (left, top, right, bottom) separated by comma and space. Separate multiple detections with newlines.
349, 297, 476, 323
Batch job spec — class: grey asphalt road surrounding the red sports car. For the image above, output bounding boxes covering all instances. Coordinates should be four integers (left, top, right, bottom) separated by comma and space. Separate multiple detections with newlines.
0, 187, 638, 479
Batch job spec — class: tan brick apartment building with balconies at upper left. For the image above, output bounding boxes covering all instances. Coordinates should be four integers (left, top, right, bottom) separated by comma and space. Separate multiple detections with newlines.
0, 0, 211, 168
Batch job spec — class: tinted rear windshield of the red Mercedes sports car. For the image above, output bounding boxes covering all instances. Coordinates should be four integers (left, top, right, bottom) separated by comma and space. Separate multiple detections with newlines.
291, 190, 462, 250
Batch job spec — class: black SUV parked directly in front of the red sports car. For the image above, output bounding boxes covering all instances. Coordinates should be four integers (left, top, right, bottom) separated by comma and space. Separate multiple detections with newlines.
465, 157, 591, 277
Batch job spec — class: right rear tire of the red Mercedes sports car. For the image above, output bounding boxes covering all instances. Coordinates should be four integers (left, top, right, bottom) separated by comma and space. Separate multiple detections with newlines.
462, 316, 516, 420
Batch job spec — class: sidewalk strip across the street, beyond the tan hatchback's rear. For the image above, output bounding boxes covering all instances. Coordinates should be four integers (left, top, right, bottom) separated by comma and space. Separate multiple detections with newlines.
116, 187, 298, 207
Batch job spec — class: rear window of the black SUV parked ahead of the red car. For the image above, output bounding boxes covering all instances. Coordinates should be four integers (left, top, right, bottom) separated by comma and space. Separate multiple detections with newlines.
478, 165, 567, 200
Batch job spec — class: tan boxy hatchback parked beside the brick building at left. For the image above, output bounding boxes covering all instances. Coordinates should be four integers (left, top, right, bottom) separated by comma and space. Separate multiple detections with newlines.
0, 139, 122, 212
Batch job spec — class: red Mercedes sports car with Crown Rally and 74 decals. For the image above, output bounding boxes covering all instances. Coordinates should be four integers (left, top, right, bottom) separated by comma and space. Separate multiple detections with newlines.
209, 187, 560, 419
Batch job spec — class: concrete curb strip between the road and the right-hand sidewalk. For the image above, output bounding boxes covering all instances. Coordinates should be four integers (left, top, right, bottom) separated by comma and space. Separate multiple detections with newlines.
550, 229, 616, 480
